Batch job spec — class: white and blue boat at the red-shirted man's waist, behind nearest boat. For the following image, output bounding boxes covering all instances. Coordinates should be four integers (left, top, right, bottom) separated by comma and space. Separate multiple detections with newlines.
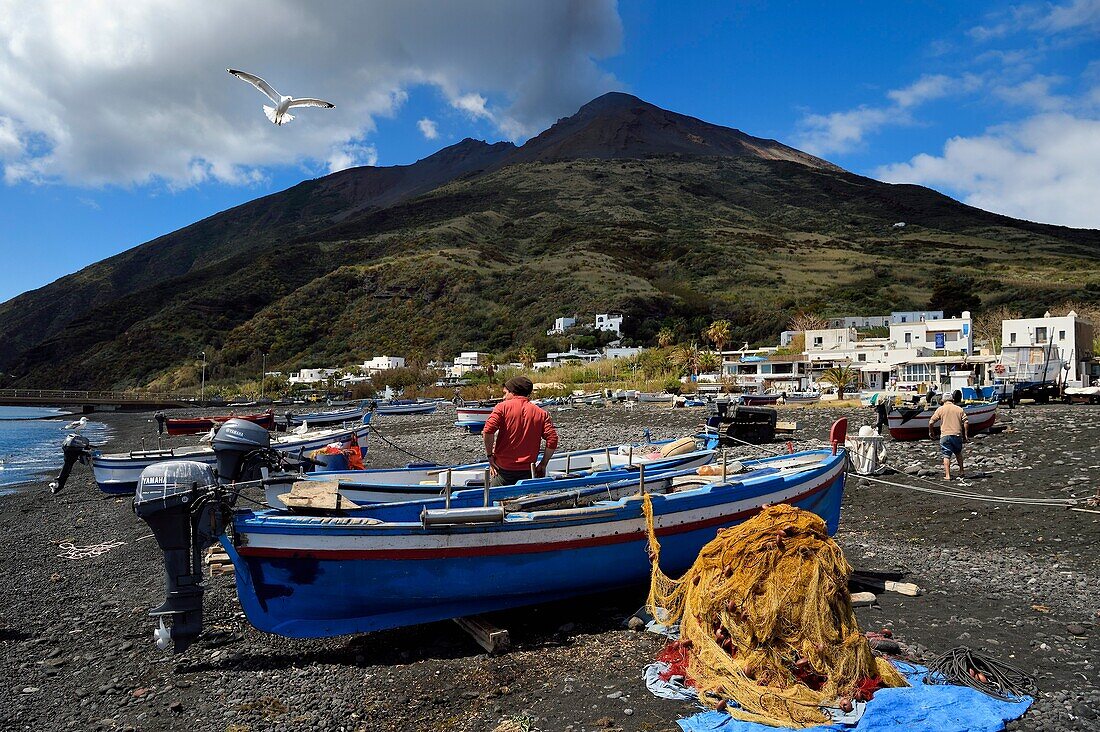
275, 436, 717, 507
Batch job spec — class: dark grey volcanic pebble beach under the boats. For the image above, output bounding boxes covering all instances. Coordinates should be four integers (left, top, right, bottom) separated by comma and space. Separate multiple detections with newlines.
0, 404, 1100, 732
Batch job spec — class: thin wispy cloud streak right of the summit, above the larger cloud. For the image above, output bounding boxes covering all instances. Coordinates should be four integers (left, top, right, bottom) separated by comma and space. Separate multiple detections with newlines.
796, 74, 982, 155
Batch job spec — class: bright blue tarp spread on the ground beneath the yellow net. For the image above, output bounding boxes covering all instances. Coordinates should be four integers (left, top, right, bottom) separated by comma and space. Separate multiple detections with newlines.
677, 664, 1034, 732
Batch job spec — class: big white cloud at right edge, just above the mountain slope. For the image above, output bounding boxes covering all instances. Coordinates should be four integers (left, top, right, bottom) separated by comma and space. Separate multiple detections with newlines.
876, 113, 1100, 228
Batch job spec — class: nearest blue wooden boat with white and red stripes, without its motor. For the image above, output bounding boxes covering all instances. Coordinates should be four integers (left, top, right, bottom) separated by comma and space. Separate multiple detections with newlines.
221, 442, 846, 637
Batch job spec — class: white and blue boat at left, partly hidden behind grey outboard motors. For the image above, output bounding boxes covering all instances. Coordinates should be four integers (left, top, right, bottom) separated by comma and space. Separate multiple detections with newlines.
90, 420, 371, 494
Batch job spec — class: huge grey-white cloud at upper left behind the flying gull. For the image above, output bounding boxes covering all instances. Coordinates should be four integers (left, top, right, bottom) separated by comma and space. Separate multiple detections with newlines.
0, 0, 623, 187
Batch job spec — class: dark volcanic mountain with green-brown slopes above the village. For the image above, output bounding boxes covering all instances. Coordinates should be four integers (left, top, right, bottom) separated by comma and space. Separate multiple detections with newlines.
0, 95, 1100, 387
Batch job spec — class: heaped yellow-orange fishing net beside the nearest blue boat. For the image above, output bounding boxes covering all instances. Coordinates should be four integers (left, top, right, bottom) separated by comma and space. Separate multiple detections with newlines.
642, 494, 906, 726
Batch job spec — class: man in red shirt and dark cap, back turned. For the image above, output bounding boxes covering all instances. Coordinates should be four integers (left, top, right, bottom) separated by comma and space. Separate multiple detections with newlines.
482, 376, 558, 485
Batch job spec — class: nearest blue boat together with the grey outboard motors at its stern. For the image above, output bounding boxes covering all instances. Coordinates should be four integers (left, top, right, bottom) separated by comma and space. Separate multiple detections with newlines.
134, 419, 847, 652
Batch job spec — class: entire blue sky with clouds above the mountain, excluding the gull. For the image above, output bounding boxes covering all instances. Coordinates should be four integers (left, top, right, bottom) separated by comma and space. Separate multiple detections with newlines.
0, 0, 1100, 301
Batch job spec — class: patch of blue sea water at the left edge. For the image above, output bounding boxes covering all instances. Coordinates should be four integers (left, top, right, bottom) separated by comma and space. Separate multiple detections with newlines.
0, 406, 110, 493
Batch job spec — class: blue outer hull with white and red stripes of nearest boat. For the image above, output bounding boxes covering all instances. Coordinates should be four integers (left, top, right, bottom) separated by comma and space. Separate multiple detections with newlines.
222, 456, 845, 637
